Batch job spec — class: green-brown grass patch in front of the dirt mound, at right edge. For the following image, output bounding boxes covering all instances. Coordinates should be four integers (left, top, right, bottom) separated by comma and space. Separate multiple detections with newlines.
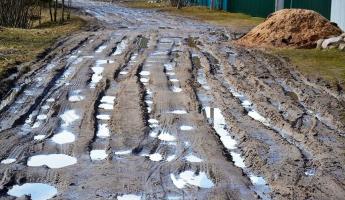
270, 49, 345, 89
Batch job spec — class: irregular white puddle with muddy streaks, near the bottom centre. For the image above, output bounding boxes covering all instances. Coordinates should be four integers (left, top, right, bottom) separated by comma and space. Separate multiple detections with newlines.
170, 170, 214, 189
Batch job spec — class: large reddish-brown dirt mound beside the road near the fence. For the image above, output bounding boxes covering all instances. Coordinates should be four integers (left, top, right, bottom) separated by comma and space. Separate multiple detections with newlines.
237, 9, 342, 48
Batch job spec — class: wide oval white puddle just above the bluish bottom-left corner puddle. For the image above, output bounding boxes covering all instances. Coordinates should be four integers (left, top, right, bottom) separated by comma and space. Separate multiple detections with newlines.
27, 154, 77, 169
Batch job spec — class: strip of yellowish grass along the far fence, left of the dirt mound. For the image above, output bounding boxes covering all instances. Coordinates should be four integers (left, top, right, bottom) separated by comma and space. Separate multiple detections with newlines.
124, 1, 264, 30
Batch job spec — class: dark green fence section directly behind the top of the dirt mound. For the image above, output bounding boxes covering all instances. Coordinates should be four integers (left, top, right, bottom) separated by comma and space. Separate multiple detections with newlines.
284, 0, 330, 19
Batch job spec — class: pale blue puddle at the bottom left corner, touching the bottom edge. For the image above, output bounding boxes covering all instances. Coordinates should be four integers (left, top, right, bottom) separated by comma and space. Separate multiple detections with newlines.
7, 183, 57, 200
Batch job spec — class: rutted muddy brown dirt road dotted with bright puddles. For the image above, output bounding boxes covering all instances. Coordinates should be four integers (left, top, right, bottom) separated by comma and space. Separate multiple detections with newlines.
0, 0, 345, 199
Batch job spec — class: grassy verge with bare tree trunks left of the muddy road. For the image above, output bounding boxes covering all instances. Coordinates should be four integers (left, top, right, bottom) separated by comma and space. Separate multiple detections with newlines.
0, 10, 86, 79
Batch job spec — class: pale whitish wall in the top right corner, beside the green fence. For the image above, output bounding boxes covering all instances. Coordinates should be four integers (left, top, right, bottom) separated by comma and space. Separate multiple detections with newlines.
331, 0, 345, 31
